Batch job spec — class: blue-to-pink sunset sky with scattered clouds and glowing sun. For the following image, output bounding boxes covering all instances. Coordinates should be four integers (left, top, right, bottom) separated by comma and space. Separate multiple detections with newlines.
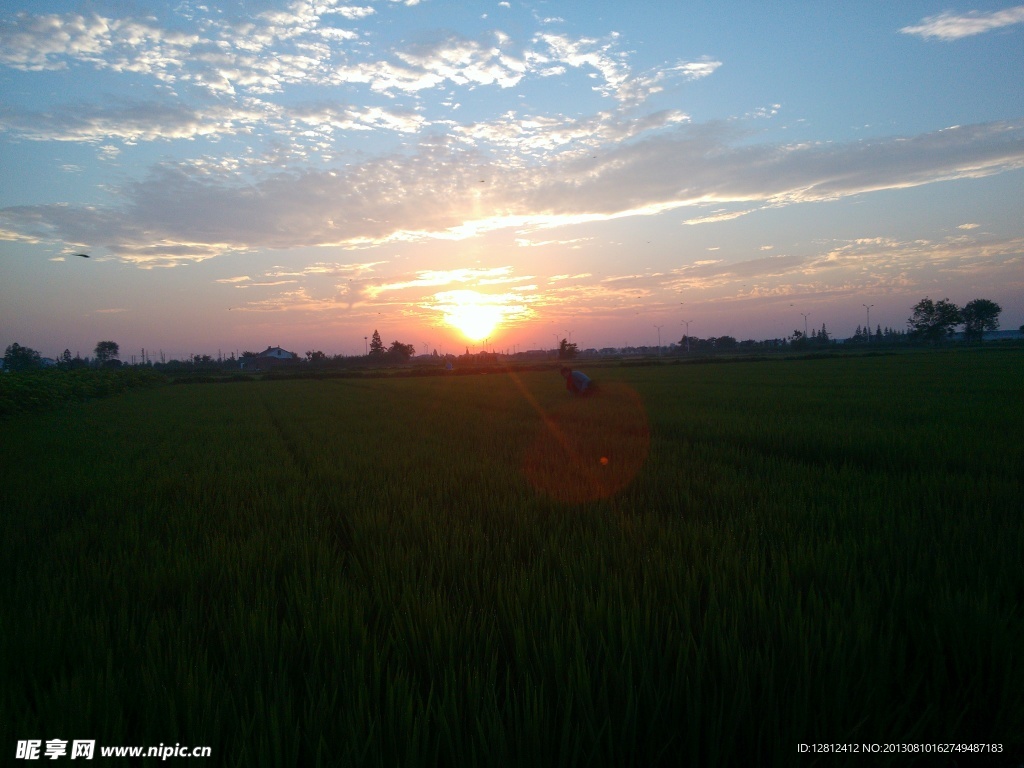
0, 0, 1024, 359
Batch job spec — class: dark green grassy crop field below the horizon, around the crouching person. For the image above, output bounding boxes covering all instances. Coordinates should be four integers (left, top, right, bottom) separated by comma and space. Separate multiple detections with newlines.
0, 349, 1024, 766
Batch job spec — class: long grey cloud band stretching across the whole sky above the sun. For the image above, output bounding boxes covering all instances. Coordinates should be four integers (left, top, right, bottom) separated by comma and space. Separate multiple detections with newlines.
0, 123, 1024, 261
